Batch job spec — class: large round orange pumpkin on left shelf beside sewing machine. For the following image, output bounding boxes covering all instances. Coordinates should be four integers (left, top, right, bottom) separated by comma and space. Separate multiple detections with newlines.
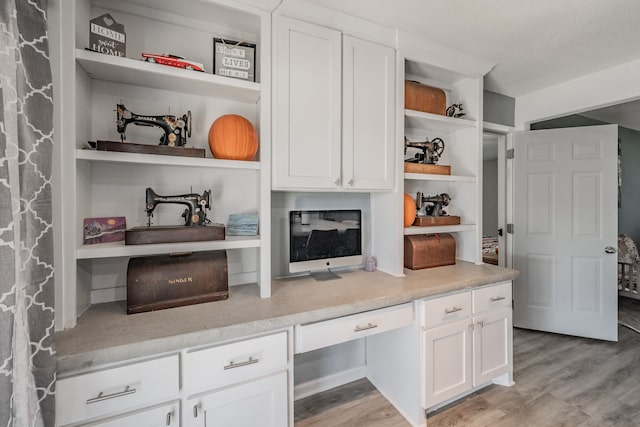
209, 114, 258, 160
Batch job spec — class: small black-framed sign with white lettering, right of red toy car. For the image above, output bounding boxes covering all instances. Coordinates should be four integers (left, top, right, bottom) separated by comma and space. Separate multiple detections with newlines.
213, 37, 256, 82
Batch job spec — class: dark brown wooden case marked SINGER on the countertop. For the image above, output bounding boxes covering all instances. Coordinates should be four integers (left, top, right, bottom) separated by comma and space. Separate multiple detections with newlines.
127, 250, 229, 314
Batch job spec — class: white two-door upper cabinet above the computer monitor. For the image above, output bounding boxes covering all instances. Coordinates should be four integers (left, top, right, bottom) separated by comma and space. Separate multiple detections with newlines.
272, 16, 395, 191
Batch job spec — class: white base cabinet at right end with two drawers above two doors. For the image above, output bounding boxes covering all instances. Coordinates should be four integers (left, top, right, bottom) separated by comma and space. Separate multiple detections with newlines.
422, 282, 513, 409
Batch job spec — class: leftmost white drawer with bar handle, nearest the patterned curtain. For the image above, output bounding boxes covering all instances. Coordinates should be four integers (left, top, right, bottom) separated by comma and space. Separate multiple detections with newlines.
56, 354, 180, 425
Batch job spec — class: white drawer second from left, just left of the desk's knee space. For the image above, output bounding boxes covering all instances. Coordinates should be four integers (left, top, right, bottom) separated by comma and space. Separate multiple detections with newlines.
184, 331, 288, 394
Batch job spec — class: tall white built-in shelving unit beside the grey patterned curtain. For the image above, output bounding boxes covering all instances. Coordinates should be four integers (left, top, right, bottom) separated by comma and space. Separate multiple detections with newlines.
54, 0, 271, 329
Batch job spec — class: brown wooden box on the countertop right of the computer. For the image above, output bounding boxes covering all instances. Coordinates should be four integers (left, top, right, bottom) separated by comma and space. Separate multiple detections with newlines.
404, 233, 456, 270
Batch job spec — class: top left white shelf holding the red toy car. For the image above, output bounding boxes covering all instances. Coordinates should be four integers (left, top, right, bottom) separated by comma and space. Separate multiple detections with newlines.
76, 49, 260, 104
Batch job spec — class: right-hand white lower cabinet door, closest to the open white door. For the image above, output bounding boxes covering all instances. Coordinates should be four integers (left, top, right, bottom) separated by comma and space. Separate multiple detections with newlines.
473, 308, 513, 386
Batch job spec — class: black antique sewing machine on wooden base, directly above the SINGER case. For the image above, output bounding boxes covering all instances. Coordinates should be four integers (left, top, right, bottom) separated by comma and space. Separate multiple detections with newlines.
125, 188, 225, 245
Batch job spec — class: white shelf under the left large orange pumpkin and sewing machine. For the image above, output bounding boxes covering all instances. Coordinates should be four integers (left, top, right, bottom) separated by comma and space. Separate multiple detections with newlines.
76, 148, 260, 170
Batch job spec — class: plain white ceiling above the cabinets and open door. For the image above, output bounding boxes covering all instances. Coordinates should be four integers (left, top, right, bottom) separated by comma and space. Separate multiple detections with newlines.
311, 0, 640, 97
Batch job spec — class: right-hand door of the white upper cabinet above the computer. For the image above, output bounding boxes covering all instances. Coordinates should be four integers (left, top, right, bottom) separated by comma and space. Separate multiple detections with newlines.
342, 36, 395, 190
